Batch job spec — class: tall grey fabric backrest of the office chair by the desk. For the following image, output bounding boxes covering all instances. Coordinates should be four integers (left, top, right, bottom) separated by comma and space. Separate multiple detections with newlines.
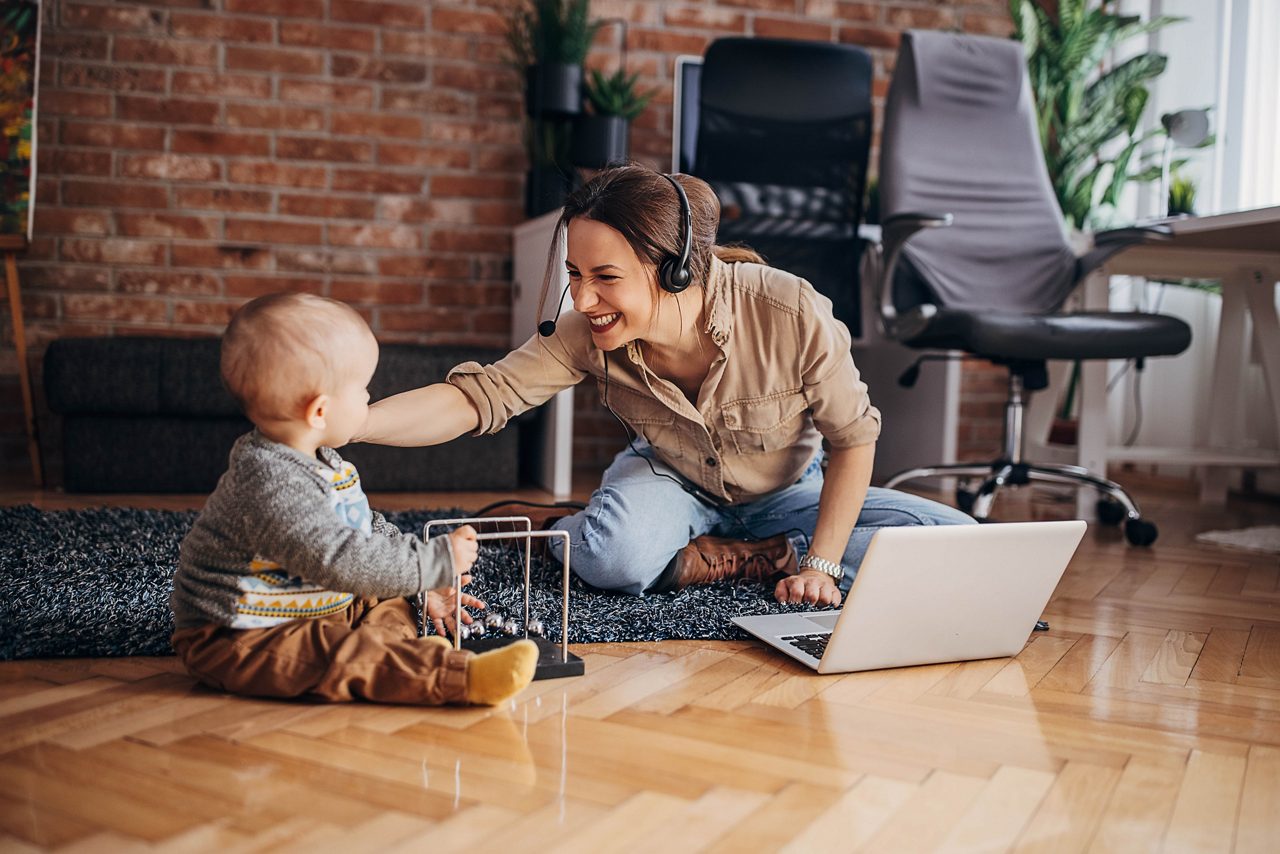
879, 31, 1076, 314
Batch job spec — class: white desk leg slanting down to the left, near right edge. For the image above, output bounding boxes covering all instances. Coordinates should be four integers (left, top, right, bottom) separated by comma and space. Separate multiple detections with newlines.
1199, 273, 1249, 504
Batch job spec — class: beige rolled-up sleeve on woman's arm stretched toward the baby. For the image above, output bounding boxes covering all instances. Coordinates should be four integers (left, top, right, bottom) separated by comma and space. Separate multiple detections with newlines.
444, 316, 589, 435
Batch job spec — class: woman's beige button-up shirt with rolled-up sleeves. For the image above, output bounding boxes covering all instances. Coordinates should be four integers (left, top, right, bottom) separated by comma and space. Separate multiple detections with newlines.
447, 257, 881, 502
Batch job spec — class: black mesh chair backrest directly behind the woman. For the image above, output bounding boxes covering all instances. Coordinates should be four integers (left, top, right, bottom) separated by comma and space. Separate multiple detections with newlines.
692, 37, 872, 337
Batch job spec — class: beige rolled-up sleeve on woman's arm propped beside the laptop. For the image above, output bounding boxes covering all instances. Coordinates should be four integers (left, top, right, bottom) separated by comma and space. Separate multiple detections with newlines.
799, 284, 881, 448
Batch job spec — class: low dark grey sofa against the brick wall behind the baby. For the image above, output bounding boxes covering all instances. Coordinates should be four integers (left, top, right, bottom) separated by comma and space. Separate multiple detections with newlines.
45, 337, 520, 493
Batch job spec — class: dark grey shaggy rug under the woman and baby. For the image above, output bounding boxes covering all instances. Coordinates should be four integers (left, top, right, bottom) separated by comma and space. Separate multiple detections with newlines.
0, 506, 805, 661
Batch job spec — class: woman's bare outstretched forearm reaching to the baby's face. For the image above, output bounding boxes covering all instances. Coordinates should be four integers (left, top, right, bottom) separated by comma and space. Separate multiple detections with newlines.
352, 383, 480, 447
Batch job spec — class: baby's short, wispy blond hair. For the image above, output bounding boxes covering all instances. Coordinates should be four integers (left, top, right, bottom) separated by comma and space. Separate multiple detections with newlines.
221, 293, 372, 424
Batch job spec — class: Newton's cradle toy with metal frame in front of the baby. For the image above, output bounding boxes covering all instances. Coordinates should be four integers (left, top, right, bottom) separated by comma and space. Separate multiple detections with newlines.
417, 516, 586, 680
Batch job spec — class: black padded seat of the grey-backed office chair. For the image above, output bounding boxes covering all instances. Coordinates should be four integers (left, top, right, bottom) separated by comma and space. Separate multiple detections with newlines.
904, 309, 1192, 360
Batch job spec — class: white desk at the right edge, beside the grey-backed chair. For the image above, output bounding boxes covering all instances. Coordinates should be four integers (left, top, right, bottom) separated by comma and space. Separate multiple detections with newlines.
1049, 206, 1280, 511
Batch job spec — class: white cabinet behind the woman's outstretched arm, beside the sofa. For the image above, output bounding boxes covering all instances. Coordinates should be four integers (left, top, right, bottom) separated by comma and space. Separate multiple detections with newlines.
511, 210, 573, 501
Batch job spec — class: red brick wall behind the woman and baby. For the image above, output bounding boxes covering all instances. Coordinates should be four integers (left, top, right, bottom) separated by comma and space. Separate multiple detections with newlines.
0, 0, 1011, 481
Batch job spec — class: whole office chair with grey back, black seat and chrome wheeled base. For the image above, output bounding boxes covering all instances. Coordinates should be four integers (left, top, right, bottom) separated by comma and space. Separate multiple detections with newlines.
877, 31, 1190, 545
